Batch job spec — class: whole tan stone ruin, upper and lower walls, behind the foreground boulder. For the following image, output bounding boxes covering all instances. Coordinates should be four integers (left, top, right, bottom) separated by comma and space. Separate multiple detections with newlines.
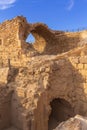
0, 16, 87, 130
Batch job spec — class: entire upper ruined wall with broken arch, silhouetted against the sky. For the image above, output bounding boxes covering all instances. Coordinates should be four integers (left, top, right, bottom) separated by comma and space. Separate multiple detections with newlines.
0, 16, 87, 66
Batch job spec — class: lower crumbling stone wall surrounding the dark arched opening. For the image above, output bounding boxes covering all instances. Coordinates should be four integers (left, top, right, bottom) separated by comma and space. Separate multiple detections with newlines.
3, 50, 87, 130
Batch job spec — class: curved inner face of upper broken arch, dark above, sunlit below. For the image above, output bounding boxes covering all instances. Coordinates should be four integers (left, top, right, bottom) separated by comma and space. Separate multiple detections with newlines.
31, 24, 52, 53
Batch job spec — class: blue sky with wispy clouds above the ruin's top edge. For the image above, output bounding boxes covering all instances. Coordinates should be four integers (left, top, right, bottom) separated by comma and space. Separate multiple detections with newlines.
0, 0, 87, 30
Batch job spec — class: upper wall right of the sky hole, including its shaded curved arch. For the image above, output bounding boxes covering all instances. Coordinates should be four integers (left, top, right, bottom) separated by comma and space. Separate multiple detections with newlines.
24, 23, 87, 55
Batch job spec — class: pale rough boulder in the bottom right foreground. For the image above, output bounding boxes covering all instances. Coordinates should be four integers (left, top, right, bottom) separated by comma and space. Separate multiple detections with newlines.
54, 115, 87, 130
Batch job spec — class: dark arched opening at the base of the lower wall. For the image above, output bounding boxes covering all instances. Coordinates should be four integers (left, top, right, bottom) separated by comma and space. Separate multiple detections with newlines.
48, 98, 75, 130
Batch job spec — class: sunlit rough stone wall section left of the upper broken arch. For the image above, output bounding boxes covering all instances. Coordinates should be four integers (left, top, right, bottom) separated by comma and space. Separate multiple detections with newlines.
0, 16, 29, 66
